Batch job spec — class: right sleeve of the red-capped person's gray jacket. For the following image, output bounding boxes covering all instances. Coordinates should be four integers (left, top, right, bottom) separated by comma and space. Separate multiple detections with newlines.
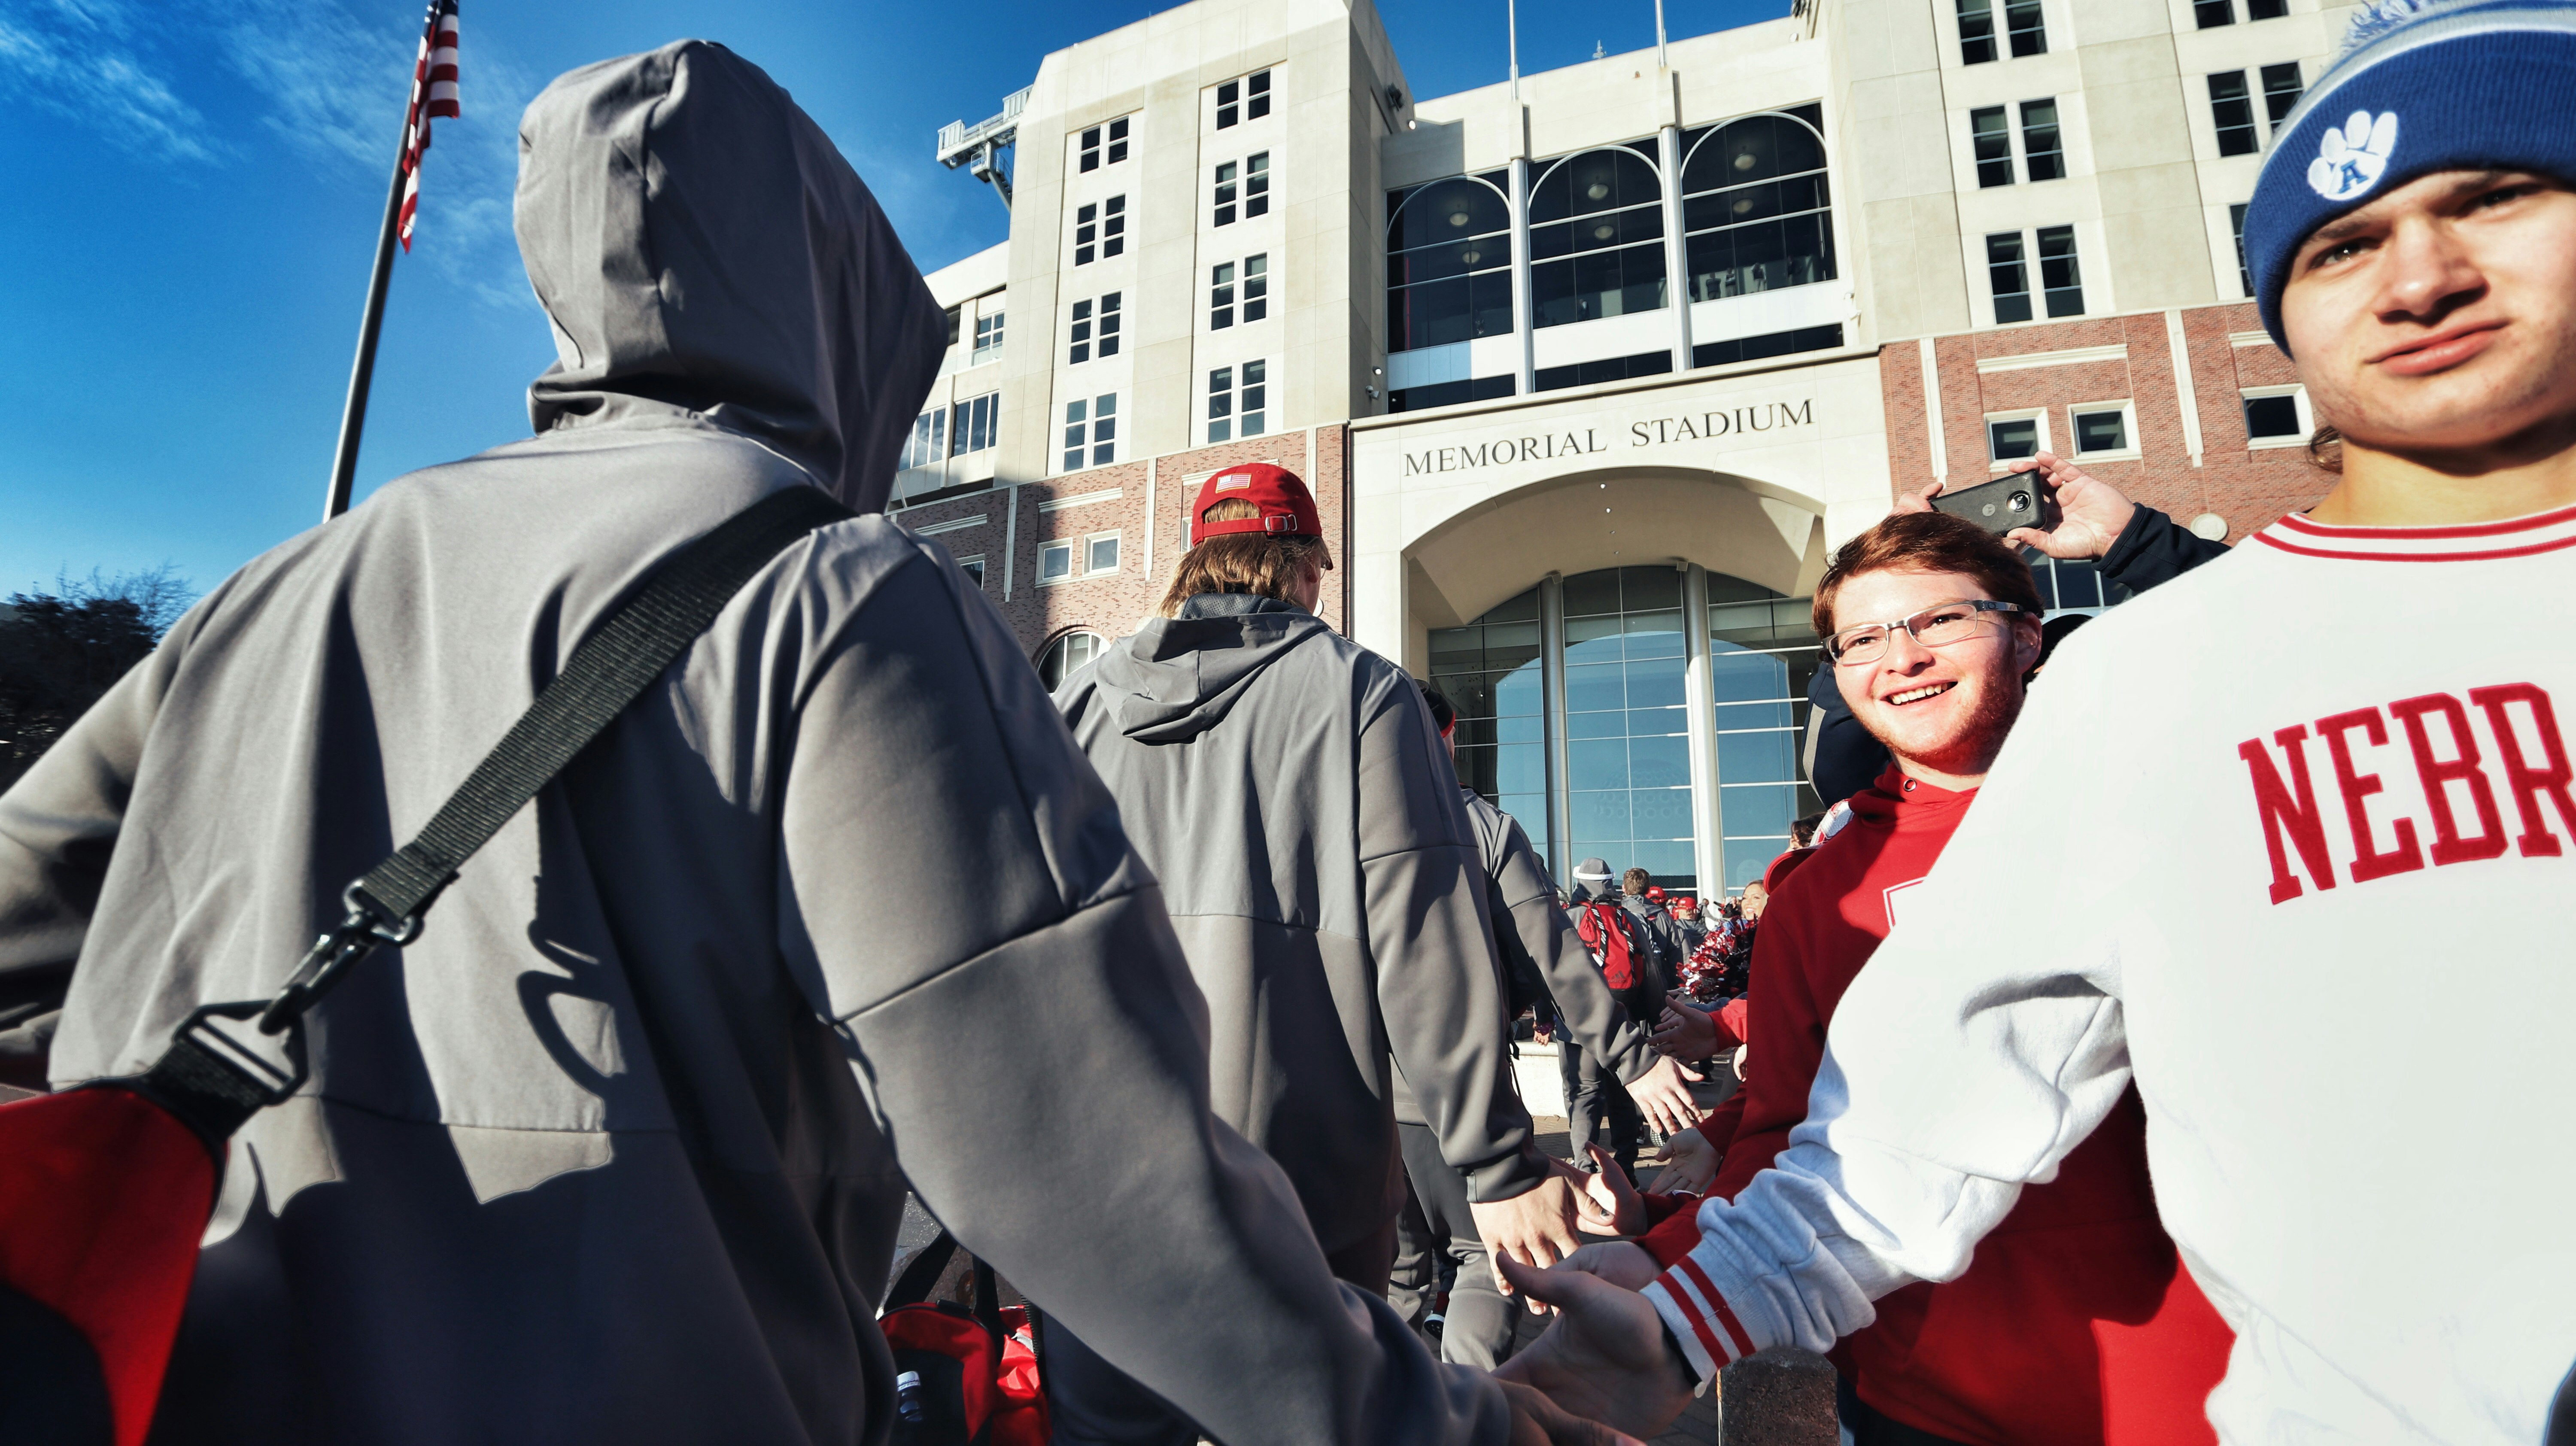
1358, 665, 1546, 1204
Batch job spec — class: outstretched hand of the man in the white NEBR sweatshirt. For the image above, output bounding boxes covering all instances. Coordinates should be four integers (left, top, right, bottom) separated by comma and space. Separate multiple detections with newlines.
1494, 1248, 1692, 1436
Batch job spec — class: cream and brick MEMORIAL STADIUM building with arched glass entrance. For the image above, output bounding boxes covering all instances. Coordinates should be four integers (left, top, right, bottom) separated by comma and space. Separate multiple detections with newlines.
896, 0, 2349, 889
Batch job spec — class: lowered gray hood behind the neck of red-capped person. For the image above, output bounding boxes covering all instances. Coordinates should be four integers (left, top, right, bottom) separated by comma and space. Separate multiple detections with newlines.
1092, 593, 1324, 742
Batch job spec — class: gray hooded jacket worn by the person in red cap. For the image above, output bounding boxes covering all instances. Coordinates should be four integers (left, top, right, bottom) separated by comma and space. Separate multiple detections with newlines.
1056, 593, 1546, 1253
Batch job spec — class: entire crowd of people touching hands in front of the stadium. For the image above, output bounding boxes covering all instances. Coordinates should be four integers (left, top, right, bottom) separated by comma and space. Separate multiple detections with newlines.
0, 0, 2576, 1446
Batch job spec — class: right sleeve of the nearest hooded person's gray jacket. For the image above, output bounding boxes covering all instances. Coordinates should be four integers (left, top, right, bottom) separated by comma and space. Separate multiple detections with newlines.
781, 554, 1510, 1446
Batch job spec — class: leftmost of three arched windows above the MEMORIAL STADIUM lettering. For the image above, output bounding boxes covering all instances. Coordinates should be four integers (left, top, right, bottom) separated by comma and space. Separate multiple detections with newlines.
1386, 170, 1512, 350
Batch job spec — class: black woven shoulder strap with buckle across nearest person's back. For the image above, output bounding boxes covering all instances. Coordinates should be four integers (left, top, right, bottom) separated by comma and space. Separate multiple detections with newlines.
144, 487, 855, 1139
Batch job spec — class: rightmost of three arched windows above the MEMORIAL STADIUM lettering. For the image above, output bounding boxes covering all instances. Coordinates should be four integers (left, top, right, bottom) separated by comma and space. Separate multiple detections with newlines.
1680, 106, 1834, 301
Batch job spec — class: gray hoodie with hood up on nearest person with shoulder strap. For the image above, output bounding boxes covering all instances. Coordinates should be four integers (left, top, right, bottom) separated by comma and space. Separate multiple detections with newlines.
0, 41, 1504, 1446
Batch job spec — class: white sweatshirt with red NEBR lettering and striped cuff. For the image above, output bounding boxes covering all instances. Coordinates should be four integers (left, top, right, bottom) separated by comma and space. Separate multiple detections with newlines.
1649, 508, 2576, 1443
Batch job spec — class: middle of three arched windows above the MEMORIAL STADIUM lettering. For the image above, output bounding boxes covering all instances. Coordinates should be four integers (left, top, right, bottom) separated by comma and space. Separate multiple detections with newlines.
1530, 142, 1664, 327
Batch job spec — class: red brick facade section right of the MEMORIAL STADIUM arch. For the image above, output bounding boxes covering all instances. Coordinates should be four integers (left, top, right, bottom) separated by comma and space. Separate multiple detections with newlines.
1878, 301, 2334, 541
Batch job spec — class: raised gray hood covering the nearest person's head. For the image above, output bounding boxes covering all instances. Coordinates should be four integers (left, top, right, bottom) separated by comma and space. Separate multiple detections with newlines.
515, 41, 945, 513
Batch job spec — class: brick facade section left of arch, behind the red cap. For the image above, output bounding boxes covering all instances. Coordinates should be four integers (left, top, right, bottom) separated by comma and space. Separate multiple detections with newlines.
894, 423, 1350, 662
